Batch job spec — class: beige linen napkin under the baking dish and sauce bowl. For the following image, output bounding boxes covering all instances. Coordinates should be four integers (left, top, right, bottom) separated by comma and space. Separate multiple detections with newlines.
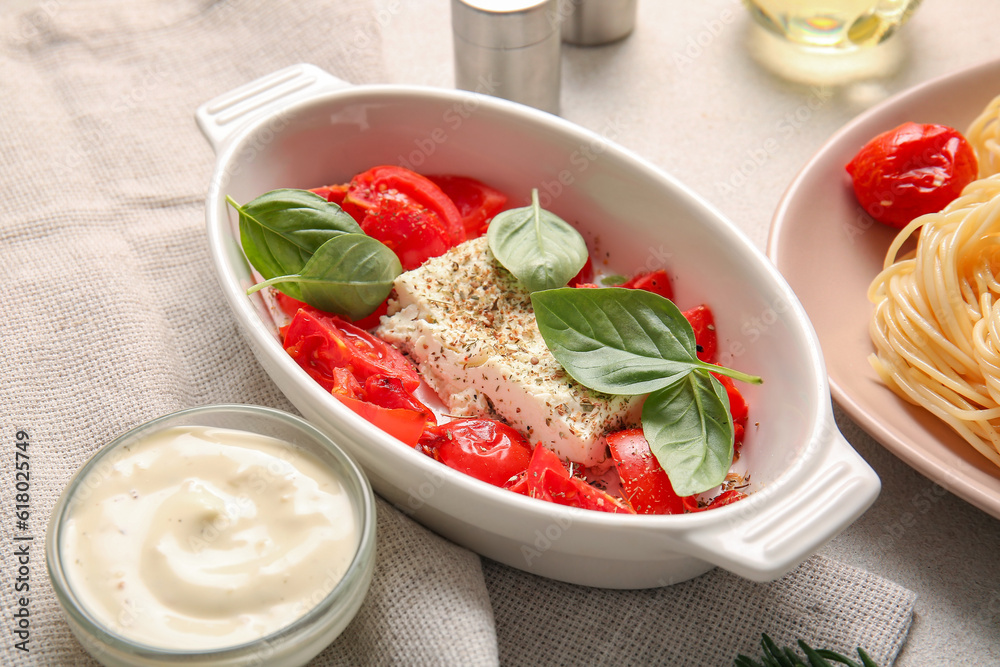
0, 0, 913, 666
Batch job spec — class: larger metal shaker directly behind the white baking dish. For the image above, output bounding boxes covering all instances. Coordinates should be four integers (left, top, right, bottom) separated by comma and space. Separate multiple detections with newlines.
451, 0, 561, 113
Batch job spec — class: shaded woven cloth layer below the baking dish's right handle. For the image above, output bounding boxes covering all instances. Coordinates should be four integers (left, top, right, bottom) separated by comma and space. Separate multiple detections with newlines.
483, 556, 916, 667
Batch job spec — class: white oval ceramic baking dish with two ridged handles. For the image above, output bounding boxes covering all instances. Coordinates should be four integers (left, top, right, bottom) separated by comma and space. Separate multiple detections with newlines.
196, 65, 880, 588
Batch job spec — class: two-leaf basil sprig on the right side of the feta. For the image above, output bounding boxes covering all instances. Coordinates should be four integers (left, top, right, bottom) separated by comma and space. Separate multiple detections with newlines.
531, 287, 761, 496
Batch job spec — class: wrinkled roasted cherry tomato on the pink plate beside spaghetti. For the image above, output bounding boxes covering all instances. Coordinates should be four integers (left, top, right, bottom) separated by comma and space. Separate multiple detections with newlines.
847, 123, 979, 227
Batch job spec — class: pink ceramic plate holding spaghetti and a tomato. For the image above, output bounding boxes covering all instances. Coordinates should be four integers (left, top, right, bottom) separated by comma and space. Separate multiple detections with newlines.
767, 60, 1000, 518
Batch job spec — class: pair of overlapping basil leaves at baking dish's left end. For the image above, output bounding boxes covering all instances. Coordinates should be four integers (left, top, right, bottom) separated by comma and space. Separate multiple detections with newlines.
226, 189, 403, 320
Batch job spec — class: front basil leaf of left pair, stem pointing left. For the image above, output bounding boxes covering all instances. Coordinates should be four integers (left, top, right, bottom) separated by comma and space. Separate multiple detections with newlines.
248, 234, 403, 320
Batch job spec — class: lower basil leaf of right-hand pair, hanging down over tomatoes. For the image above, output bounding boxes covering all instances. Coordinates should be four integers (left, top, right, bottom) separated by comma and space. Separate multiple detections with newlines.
642, 370, 733, 496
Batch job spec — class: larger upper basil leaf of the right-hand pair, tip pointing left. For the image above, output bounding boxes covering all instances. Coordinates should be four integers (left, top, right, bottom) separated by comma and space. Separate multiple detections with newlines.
531, 287, 700, 395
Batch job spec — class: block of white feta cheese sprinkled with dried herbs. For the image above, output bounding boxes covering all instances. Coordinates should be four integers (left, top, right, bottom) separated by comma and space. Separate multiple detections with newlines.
376, 237, 642, 466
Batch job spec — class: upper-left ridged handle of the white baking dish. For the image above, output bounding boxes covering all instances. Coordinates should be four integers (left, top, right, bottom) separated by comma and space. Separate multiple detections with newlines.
195, 63, 351, 153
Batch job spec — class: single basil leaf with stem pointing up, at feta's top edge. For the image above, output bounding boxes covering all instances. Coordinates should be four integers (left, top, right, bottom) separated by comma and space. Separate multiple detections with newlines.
486, 190, 588, 292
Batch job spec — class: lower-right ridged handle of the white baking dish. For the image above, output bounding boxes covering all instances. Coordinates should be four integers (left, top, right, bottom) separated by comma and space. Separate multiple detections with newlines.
684, 412, 882, 581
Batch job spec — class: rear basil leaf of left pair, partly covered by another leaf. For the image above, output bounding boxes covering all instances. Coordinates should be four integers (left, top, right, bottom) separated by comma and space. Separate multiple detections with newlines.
226, 189, 362, 300
